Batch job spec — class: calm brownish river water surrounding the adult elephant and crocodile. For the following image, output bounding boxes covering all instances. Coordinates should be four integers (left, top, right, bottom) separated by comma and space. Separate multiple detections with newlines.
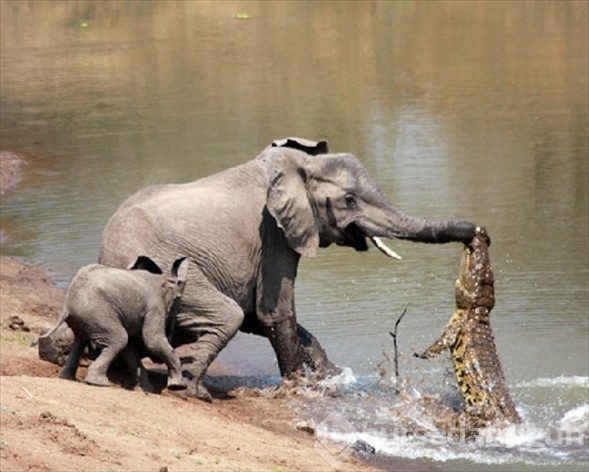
0, 1, 589, 470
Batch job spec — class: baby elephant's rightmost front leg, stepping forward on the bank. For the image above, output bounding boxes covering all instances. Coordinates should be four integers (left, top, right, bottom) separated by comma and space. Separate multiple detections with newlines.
142, 309, 187, 390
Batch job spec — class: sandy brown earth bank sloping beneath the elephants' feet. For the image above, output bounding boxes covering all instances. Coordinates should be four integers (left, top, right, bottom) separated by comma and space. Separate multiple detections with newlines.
0, 257, 374, 472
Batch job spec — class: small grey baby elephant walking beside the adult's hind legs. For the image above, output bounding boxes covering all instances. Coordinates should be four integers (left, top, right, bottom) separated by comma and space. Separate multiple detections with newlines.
41, 256, 188, 390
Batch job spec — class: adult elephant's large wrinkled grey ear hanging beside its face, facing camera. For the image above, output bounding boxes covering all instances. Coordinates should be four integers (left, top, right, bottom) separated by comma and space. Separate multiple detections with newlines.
266, 161, 319, 257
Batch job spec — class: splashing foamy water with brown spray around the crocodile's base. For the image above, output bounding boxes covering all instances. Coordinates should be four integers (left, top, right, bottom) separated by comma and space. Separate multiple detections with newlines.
295, 372, 589, 470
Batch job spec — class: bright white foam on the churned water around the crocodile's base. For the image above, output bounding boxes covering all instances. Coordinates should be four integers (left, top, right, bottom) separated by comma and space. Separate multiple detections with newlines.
308, 369, 589, 467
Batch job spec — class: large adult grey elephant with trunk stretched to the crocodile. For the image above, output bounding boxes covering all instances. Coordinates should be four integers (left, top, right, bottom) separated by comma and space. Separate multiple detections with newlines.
100, 138, 475, 400
